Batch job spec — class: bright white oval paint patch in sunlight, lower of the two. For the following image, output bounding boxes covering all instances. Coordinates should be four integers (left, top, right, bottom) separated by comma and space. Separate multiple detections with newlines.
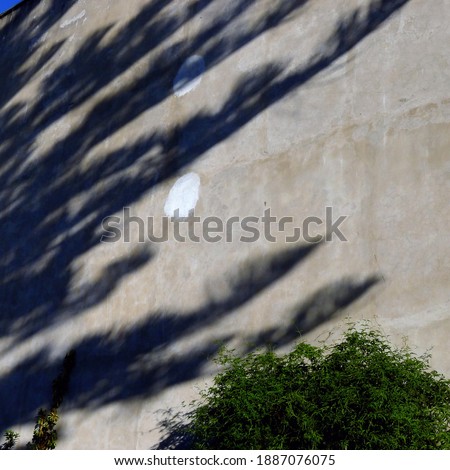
164, 173, 200, 217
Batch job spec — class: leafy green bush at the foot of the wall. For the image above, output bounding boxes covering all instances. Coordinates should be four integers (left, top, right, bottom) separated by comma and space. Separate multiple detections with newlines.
187, 327, 450, 450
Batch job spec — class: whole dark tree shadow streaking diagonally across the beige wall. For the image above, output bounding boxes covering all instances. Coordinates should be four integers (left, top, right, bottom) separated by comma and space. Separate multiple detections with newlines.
0, 0, 408, 436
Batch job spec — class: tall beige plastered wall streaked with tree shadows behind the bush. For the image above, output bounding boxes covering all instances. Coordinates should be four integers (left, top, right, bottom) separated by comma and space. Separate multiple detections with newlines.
0, 0, 450, 449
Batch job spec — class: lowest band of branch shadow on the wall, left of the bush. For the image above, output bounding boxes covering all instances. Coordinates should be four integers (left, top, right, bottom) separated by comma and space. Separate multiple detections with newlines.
0, 244, 318, 426
